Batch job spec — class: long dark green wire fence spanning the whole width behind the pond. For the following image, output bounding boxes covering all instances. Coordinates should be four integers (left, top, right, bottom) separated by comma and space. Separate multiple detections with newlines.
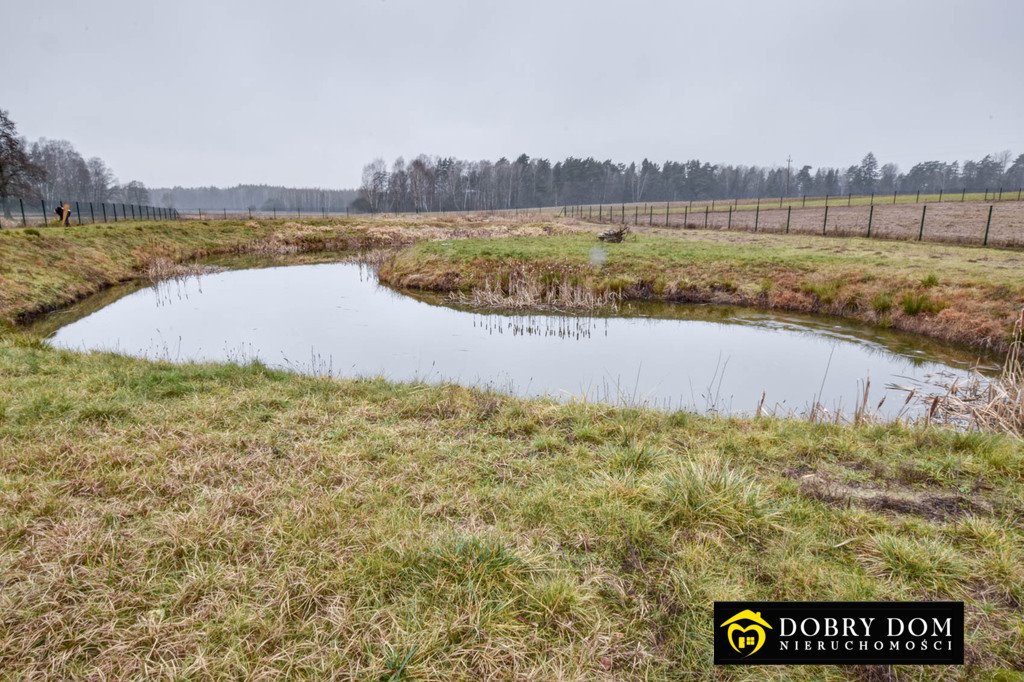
8, 188, 1024, 248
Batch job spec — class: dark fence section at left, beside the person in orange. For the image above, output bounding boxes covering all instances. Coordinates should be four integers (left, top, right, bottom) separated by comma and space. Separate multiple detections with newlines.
0, 197, 180, 227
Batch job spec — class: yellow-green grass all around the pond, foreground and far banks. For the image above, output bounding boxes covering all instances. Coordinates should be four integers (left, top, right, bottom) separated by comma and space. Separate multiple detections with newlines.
0, 216, 1024, 680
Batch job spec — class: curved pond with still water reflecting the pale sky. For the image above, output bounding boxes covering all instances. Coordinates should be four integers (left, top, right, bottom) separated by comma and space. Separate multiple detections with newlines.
48, 263, 995, 418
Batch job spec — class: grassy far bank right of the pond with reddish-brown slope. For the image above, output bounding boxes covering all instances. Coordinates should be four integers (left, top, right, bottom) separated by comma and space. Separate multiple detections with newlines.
380, 229, 1024, 351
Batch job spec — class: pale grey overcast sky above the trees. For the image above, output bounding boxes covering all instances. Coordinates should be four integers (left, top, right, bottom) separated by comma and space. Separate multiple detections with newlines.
0, 0, 1024, 187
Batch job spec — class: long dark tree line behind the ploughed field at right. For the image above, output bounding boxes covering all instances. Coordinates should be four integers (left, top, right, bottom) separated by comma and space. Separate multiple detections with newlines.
353, 152, 1024, 212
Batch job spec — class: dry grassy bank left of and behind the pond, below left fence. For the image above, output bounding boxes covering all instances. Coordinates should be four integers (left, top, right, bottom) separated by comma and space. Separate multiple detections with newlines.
0, 216, 559, 324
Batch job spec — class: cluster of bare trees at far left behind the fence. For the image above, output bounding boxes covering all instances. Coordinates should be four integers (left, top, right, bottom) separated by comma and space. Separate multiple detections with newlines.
0, 109, 150, 218
